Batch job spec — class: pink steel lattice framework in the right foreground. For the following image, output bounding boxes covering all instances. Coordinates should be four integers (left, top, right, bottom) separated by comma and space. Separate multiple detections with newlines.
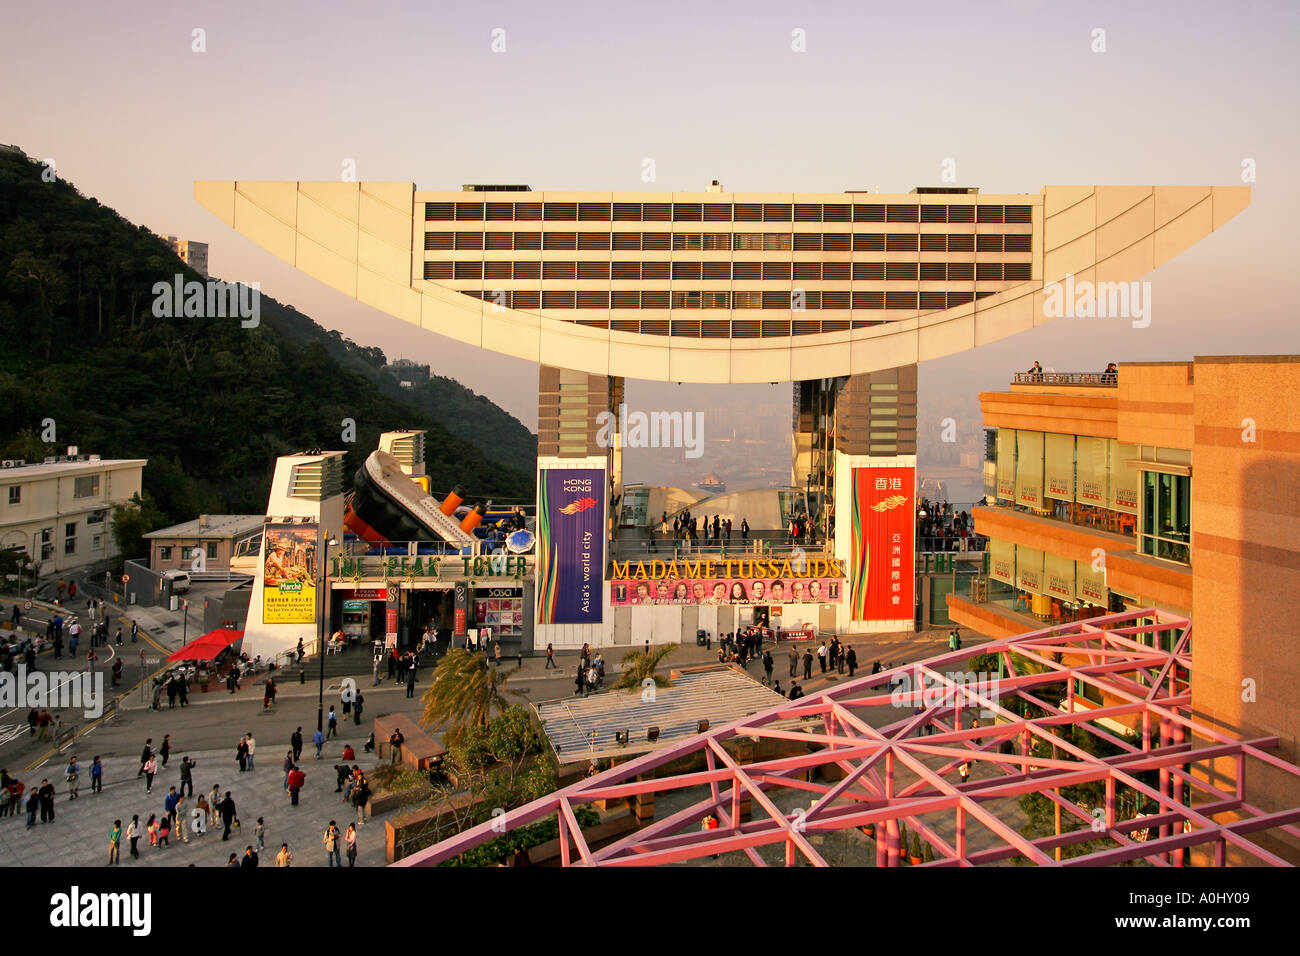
395, 609, 1300, 866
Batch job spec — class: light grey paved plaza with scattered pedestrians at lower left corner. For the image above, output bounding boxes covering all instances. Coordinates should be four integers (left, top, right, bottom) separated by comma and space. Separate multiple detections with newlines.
0, 740, 391, 868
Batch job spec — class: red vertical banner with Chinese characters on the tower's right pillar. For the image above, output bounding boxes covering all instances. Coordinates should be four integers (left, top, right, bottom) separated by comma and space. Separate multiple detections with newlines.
850, 467, 917, 620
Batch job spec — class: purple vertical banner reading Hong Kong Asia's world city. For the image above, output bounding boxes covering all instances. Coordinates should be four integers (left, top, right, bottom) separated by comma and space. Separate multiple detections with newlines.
537, 468, 605, 624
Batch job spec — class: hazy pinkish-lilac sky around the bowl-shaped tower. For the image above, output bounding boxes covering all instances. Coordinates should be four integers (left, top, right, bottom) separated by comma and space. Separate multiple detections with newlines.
0, 0, 1300, 442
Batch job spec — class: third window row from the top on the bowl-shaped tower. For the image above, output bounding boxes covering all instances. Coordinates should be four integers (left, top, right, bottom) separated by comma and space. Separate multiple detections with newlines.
424, 260, 1031, 282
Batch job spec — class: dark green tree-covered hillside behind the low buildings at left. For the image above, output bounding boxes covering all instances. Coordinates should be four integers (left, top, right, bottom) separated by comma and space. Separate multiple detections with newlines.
0, 152, 536, 538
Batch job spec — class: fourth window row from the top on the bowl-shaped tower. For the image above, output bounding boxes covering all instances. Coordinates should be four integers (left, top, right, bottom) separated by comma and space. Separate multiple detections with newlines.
452, 289, 993, 312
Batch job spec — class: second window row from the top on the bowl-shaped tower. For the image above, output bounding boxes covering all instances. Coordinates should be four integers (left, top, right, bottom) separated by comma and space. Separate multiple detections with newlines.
424, 233, 1034, 252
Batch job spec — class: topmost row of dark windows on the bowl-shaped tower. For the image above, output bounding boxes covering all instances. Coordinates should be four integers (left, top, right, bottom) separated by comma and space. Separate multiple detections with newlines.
424, 202, 1034, 222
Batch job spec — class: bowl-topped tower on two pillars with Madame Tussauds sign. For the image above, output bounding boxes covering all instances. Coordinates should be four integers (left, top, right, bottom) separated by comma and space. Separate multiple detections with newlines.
195, 181, 1251, 650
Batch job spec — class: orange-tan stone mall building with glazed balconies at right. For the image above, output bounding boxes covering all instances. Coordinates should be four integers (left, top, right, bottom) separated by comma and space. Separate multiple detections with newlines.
948, 355, 1300, 842
